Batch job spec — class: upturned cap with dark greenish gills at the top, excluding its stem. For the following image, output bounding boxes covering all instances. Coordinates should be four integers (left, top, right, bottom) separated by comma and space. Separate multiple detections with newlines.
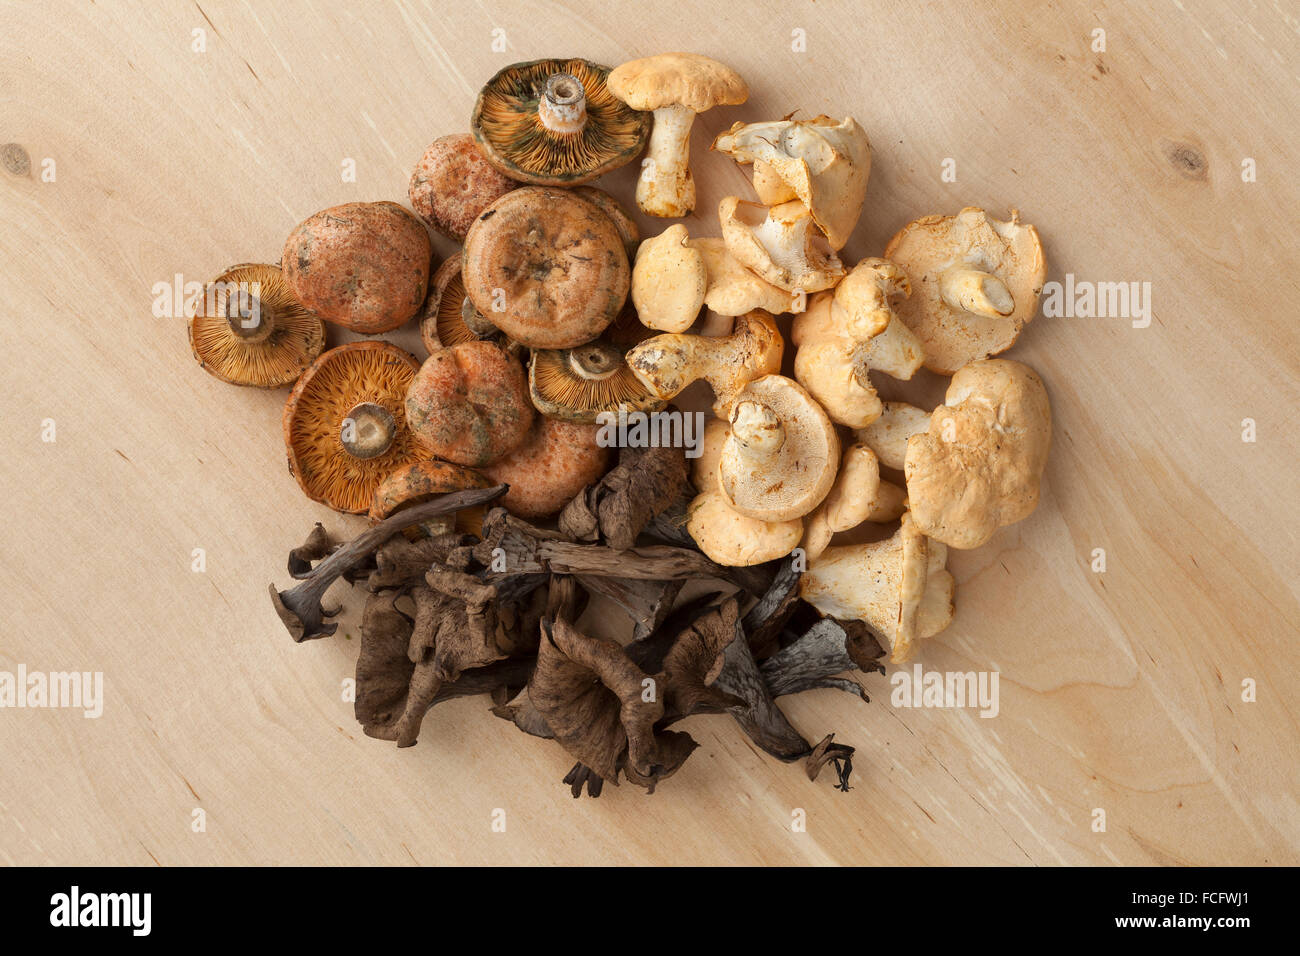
469, 60, 650, 186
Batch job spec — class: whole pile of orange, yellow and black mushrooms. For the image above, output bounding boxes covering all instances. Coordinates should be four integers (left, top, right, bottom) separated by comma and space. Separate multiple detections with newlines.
190, 53, 1052, 796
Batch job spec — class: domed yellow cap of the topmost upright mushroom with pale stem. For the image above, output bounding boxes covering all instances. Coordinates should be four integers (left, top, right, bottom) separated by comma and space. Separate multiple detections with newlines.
608, 53, 749, 113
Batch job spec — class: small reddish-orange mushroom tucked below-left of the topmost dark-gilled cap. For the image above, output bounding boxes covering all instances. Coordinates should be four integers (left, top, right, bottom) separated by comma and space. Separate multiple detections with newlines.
408, 133, 519, 242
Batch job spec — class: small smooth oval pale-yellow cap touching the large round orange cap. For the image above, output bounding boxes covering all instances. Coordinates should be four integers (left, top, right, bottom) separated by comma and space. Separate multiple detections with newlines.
632, 224, 709, 332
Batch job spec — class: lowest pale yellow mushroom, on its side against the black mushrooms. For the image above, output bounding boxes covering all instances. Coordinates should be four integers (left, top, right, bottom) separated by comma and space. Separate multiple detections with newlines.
800, 512, 954, 663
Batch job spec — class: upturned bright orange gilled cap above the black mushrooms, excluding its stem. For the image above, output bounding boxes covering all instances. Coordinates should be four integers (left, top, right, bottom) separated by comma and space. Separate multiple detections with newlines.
282, 342, 429, 514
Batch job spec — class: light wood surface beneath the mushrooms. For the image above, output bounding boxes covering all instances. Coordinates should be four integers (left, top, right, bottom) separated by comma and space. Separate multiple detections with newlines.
0, 0, 1300, 865
